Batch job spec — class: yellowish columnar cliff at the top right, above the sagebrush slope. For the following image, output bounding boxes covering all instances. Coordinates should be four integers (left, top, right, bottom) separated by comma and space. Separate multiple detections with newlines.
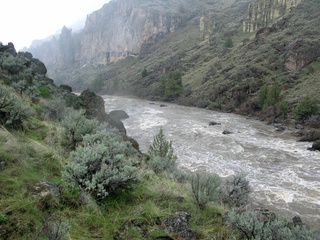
243, 0, 302, 32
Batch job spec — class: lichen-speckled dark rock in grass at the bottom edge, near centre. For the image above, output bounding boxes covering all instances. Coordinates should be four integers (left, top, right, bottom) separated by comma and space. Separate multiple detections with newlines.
163, 212, 198, 240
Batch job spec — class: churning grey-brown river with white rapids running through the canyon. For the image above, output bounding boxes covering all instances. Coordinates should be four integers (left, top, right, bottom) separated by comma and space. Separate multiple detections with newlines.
103, 96, 320, 227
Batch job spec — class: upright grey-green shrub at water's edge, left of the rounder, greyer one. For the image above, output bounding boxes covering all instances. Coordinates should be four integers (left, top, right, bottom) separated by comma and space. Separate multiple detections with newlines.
190, 172, 221, 209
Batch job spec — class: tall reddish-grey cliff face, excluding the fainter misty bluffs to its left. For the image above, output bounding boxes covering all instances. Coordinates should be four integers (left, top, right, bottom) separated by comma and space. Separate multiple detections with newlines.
81, 0, 181, 64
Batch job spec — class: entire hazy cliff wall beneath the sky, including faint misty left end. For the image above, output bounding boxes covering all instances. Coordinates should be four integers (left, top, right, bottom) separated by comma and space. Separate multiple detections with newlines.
28, 0, 181, 69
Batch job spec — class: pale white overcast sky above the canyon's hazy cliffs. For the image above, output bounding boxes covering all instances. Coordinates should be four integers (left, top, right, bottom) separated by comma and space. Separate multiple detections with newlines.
0, 0, 110, 51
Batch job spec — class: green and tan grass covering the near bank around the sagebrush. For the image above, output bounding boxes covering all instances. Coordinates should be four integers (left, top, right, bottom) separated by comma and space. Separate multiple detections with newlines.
0, 122, 230, 239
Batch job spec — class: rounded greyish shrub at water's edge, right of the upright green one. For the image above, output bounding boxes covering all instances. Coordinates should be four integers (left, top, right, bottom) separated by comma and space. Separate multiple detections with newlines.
223, 173, 251, 207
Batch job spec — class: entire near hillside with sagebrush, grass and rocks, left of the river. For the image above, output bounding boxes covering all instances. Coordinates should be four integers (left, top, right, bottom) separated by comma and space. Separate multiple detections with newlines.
0, 43, 320, 240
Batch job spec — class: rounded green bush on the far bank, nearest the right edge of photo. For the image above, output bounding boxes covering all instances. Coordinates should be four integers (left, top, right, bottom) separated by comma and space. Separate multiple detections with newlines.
294, 97, 318, 121
